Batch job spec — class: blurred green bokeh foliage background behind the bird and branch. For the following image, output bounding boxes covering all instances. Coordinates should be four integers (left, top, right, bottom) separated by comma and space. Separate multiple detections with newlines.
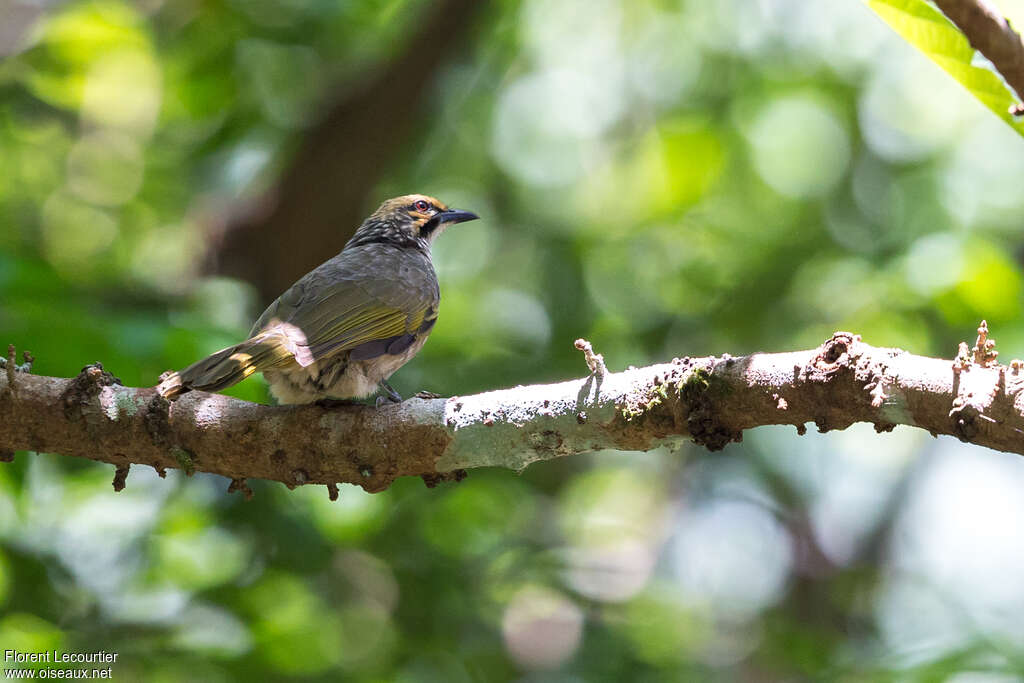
0, 0, 1024, 683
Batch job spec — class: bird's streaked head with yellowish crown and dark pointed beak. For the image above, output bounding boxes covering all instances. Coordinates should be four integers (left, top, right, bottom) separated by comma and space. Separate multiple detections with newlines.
346, 195, 479, 250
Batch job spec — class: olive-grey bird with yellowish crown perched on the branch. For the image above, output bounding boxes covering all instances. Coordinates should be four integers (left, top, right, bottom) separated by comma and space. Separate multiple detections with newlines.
157, 195, 479, 403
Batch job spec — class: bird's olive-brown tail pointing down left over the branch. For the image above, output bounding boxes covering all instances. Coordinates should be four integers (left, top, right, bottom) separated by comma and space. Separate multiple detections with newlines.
157, 327, 311, 399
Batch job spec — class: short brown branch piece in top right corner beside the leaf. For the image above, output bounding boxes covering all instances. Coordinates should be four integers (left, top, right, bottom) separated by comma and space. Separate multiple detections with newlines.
935, 0, 1024, 109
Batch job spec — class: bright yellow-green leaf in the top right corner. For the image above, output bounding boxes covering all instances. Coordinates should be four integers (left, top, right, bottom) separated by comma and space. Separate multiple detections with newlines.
866, 0, 1024, 135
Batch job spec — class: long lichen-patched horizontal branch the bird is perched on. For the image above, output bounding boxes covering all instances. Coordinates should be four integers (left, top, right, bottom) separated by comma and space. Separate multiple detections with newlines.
0, 331, 1024, 496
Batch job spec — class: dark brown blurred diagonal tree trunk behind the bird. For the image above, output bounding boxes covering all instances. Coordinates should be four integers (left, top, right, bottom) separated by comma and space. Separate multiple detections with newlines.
206, 0, 487, 303
